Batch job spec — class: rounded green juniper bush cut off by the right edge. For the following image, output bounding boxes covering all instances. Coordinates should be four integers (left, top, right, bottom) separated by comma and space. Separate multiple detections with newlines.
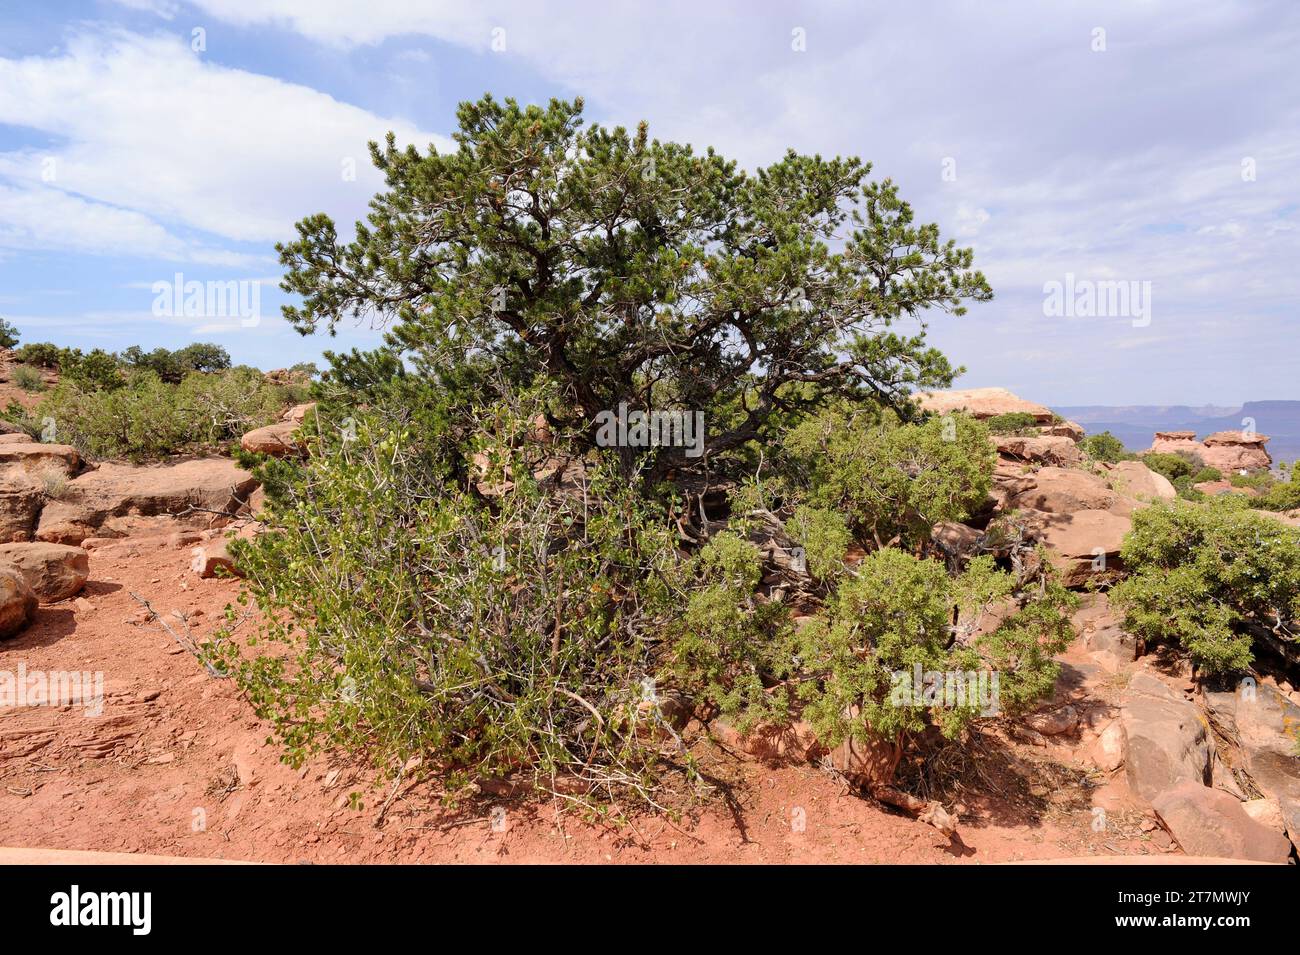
1112, 495, 1300, 672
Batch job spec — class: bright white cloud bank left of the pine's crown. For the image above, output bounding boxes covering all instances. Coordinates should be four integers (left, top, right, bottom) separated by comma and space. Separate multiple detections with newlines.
0, 32, 449, 261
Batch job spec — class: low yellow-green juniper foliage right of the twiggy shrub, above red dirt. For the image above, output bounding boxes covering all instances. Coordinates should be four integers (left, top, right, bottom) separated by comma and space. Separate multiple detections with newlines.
675, 539, 1078, 746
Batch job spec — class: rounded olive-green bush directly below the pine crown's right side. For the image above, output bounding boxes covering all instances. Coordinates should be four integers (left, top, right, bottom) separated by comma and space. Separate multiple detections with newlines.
783, 411, 997, 547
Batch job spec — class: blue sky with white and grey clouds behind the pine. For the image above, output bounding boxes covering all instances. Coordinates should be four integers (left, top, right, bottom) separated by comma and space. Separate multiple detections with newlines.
0, 0, 1300, 404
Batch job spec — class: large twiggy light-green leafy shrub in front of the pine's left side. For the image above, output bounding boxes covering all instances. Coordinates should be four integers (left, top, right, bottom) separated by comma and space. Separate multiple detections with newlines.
211, 407, 691, 791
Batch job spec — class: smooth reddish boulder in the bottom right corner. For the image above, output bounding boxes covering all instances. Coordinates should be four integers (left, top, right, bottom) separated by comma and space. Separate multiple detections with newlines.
1152, 782, 1291, 865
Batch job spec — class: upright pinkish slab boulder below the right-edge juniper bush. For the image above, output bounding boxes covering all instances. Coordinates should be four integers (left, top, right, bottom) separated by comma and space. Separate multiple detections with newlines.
1119, 672, 1211, 802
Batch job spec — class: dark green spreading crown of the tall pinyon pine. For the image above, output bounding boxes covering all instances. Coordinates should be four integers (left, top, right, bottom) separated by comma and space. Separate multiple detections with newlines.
280, 96, 992, 489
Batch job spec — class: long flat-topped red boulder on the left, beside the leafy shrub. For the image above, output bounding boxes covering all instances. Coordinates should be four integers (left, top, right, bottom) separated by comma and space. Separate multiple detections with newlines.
35, 457, 257, 544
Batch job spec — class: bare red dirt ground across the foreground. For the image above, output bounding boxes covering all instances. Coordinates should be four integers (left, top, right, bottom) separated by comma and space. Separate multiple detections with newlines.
0, 537, 1161, 863
